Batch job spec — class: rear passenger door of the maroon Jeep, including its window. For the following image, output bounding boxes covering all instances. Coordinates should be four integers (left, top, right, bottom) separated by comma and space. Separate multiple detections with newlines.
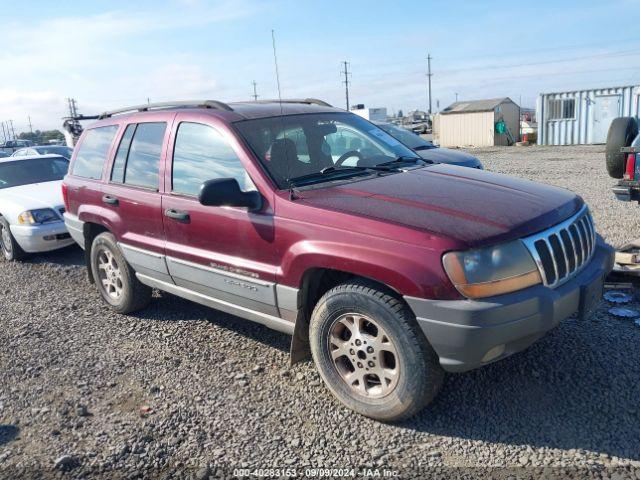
101, 121, 169, 280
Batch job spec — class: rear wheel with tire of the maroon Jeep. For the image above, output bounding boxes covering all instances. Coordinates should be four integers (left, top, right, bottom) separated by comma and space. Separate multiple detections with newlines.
90, 232, 152, 314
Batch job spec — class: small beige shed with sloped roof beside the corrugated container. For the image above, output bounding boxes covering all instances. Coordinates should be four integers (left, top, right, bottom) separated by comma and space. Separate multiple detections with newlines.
433, 97, 520, 147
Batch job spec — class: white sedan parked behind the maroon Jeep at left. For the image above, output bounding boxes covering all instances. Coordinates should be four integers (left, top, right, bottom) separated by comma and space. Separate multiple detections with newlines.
0, 155, 73, 260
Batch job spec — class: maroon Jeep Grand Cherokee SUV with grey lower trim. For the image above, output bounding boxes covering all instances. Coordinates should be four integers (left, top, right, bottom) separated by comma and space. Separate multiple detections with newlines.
63, 100, 612, 420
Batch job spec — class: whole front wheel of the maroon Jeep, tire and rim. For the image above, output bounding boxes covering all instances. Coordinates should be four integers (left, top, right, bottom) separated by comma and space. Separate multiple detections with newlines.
309, 281, 444, 422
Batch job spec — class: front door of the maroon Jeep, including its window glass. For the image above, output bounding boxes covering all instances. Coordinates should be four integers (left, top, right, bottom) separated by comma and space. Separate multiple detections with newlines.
162, 118, 278, 316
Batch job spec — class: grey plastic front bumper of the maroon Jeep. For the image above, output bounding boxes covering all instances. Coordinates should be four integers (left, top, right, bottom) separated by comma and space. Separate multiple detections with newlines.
404, 242, 613, 372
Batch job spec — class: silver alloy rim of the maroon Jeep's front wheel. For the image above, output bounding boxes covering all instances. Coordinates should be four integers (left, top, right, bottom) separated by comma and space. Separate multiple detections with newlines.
328, 313, 400, 398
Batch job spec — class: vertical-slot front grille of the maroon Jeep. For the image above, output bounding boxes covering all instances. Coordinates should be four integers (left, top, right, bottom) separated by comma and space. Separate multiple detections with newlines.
523, 205, 596, 288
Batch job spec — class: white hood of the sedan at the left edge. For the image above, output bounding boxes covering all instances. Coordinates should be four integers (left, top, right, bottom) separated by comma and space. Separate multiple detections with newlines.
0, 180, 64, 218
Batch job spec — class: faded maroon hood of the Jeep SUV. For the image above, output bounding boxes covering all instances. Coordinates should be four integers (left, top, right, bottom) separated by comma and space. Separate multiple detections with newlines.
300, 164, 583, 247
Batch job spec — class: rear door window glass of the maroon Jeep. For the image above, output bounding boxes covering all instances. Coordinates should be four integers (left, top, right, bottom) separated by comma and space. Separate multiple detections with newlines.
111, 122, 167, 190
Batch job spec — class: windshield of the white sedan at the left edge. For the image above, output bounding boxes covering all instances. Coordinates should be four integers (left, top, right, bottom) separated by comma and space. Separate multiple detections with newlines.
0, 157, 69, 189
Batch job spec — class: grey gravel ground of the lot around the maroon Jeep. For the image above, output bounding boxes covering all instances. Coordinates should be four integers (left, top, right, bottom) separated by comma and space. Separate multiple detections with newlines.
0, 147, 640, 479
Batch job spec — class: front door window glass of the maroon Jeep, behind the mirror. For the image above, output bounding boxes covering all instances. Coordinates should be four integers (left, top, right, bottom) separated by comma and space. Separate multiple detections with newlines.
173, 122, 255, 195
